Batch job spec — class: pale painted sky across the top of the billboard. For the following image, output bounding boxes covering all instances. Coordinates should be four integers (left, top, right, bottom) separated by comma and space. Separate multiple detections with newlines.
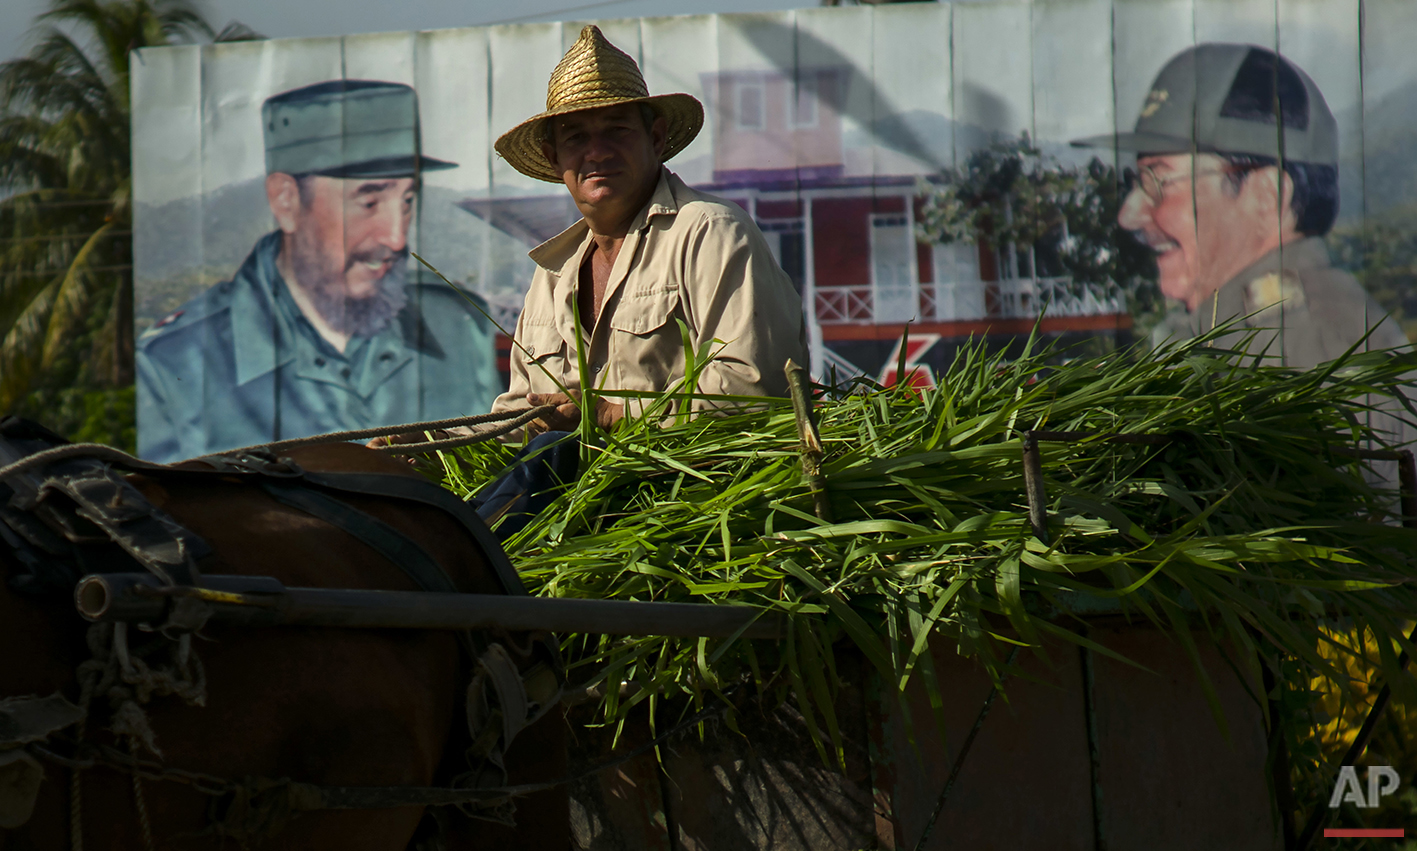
135, 0, 1394, 202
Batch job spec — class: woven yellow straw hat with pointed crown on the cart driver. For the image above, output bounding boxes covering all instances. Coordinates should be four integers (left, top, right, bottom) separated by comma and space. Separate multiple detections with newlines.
496, 25, 704, 183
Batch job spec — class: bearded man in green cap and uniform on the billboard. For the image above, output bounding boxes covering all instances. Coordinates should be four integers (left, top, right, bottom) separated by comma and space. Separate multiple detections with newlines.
137, 79, 497, 462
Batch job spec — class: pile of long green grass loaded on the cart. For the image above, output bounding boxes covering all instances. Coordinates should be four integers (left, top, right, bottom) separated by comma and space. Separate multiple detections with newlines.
430, 331, 1417, 764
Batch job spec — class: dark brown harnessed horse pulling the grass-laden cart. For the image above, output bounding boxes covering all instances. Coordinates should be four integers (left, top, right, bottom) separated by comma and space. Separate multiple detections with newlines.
0, 424, 571, 851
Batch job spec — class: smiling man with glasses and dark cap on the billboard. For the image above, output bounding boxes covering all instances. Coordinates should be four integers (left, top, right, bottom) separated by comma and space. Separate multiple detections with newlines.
1073, 44, 1407, 368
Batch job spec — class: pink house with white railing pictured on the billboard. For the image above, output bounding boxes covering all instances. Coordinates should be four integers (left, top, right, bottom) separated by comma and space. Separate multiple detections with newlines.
703, 68, 1131, 375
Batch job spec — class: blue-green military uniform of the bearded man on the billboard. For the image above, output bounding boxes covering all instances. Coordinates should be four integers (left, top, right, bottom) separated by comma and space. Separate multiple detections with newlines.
137, 231, 500, 462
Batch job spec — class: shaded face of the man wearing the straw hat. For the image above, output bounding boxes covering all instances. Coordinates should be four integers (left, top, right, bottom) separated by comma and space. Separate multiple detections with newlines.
543, 103, 666, 223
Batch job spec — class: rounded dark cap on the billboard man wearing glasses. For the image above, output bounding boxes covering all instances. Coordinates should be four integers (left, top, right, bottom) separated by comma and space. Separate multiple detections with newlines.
1073, 42, 1338, 166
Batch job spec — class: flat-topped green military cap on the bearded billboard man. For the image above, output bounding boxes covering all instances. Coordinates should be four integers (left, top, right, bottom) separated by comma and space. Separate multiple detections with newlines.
261, 79, 458, 178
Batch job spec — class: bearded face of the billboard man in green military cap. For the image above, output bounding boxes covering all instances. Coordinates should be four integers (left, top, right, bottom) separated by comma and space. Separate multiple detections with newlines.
281, 176, 417, 336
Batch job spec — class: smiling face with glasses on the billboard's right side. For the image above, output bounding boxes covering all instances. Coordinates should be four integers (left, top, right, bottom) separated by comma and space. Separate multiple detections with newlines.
1117, 154, 1285, 310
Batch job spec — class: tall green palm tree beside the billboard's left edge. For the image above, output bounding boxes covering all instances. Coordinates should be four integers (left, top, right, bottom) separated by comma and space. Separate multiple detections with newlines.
0, 0, 259, 438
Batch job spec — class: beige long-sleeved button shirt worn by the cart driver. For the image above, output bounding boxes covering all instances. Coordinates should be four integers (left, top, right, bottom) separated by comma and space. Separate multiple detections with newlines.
492, 169, 808, 415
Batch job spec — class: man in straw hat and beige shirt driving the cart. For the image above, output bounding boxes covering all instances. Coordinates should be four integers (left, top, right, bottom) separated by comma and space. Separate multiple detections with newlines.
493, 27, 806, 430
